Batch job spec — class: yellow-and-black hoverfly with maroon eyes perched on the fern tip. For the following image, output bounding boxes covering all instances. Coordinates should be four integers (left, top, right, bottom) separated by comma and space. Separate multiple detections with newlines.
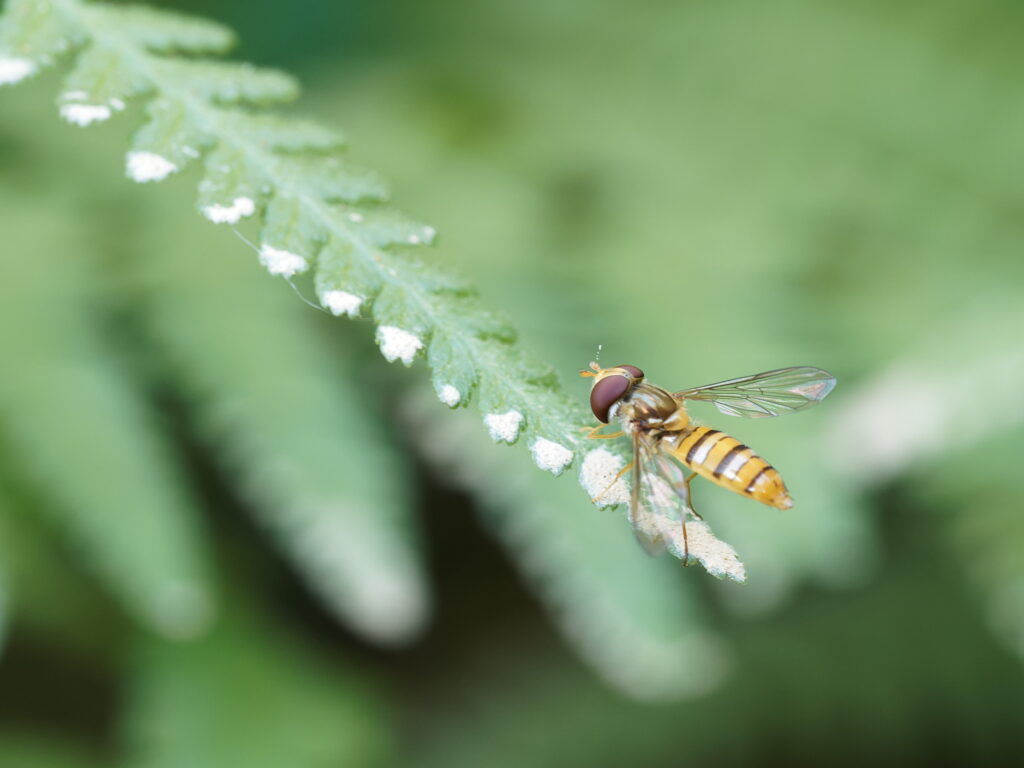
580, 362, 836, 564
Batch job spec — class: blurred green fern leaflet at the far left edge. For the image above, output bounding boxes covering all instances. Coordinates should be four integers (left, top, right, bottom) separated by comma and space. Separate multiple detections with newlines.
0, 198, 213, 636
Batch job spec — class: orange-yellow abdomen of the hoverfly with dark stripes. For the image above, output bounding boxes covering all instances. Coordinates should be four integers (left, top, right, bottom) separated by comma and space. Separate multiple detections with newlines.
672, 427, 793, 509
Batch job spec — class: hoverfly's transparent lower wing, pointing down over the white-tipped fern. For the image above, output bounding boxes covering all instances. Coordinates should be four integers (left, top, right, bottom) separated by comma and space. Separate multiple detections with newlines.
630, 433, 691, 555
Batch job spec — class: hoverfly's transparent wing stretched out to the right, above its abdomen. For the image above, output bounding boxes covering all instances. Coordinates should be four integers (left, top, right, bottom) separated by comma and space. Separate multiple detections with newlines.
673, 367, 836, 419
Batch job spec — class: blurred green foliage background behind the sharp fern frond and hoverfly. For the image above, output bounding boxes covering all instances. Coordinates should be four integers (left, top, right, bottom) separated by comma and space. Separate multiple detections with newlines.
0, 0, 1024, 768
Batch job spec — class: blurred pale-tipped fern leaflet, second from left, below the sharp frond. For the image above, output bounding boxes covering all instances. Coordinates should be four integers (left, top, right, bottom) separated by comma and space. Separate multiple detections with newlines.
135, 208, 429, 643
